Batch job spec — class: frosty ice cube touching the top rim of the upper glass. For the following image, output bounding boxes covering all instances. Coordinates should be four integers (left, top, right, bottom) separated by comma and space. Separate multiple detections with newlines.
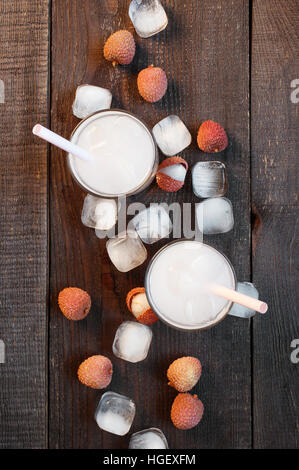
73, 85, 112, 119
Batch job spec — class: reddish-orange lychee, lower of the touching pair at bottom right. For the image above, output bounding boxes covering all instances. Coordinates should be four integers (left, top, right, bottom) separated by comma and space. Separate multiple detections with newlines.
171, 393, 204, 430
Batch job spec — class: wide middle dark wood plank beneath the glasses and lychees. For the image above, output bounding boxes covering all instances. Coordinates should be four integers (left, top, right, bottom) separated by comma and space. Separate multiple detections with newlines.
50, 0, 251, 448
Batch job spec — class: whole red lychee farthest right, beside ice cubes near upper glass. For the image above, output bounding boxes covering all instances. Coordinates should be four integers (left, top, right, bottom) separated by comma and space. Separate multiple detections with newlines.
197, 121, 228, 153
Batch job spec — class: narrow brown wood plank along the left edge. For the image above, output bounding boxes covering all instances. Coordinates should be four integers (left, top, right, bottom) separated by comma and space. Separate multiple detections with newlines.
0, 0, 49, 448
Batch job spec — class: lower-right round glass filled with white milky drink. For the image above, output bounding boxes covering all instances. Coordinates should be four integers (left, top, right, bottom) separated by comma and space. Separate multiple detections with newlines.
145, 240, 236, 330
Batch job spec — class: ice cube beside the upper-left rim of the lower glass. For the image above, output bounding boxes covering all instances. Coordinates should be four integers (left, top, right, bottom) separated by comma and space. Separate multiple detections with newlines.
106, 230, 147, 273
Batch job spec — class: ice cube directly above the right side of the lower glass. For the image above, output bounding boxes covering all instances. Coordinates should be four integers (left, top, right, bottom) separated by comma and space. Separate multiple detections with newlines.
196, 197, 234, 235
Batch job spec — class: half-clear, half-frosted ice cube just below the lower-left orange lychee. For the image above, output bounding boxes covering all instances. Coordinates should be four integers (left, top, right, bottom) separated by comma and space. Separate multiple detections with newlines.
95, 392, 136, 436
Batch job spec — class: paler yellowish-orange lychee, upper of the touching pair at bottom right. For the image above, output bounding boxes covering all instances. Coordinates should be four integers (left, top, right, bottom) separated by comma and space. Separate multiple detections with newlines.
167, 357, 202, 392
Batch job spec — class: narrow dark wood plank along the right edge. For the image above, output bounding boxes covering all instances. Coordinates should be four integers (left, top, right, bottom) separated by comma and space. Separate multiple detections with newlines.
252, 0, 299, 448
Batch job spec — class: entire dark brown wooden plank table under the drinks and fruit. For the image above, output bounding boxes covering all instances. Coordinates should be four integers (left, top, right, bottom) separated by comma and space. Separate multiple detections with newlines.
0, 0, 299, 449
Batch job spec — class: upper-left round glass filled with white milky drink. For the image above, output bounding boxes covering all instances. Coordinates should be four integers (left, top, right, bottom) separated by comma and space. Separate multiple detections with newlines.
68, 109, 159, 198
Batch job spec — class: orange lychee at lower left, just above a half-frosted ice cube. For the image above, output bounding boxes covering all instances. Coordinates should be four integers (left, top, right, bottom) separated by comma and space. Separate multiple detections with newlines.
78, 356, 113, 389
